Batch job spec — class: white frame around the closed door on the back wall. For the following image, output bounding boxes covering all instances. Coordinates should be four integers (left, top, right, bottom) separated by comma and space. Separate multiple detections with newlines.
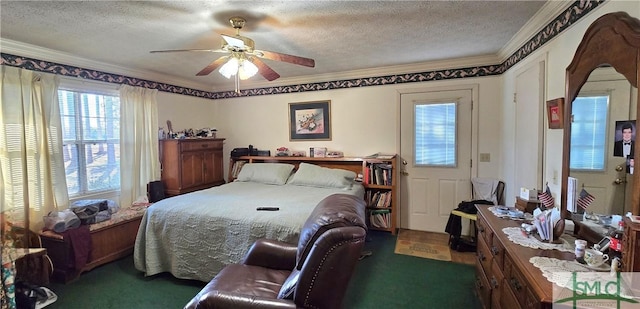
396, 84, 480, 228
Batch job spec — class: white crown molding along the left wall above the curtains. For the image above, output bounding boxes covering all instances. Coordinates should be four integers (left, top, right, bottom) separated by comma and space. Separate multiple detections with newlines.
0, 38, 211, 91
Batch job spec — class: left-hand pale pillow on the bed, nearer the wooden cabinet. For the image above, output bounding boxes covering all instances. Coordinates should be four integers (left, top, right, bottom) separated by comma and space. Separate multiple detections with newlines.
236, 163, 294, 185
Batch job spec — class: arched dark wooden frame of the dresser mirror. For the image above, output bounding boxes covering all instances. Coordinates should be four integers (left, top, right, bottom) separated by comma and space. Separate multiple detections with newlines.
560, 12, 640, 218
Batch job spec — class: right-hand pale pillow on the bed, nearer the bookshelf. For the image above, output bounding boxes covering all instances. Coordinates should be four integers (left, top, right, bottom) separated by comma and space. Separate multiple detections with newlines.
287, 162, 356, 189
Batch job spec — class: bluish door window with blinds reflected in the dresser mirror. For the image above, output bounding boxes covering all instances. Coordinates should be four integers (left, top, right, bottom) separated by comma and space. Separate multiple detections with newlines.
569, 95, 609, 171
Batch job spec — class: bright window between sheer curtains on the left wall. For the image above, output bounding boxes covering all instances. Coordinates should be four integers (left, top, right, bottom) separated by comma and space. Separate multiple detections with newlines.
58, 88, 120, 196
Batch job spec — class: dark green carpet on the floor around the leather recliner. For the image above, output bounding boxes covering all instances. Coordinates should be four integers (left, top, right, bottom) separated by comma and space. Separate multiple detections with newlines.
46, 231, 481, 309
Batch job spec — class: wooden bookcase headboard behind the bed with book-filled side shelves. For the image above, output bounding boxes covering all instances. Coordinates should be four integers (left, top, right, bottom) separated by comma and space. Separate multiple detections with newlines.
228, 155, 398, 235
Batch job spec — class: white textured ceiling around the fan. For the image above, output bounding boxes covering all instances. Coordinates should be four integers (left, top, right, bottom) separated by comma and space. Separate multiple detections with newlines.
0, 0, 545, 91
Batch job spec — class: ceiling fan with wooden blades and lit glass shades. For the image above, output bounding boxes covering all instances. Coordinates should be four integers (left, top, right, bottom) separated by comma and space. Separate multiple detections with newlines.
151, 16, 315, 85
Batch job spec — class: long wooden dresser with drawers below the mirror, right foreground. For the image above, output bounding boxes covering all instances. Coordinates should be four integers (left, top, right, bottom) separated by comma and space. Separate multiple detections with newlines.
476, 206, 575, 309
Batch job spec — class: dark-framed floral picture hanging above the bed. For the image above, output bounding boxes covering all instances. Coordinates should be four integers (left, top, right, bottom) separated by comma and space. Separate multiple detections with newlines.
289, 100, 331, 141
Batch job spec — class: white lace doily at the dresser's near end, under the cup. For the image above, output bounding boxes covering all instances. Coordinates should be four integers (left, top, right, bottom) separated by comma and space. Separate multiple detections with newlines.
529, 256, 635, 298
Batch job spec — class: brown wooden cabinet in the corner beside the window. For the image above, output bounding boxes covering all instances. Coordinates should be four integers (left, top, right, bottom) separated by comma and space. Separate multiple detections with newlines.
160, 138, 224, 196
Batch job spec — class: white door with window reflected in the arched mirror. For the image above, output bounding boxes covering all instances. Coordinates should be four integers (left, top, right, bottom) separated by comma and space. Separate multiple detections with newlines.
570, 80, 631, 214
